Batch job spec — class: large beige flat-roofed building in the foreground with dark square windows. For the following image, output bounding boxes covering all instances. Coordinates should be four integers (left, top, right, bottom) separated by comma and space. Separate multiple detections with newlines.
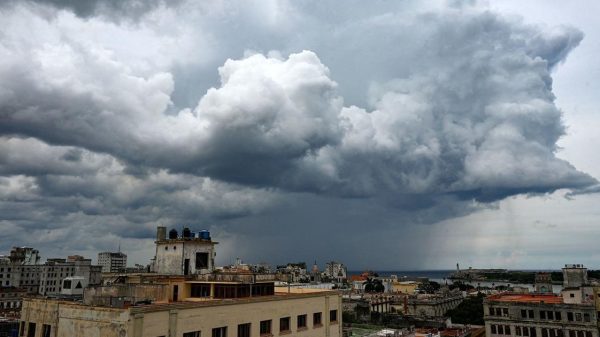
20, 288, 342, 337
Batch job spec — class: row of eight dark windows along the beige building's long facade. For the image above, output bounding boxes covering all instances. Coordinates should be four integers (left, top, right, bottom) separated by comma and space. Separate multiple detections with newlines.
178, 310, 338, 337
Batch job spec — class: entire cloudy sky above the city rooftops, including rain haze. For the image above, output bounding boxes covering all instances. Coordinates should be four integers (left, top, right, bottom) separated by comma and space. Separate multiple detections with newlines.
0, 0, 600, 270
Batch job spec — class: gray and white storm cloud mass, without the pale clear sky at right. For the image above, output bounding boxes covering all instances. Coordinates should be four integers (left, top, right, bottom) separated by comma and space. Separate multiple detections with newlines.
0, 1, 597, 266
